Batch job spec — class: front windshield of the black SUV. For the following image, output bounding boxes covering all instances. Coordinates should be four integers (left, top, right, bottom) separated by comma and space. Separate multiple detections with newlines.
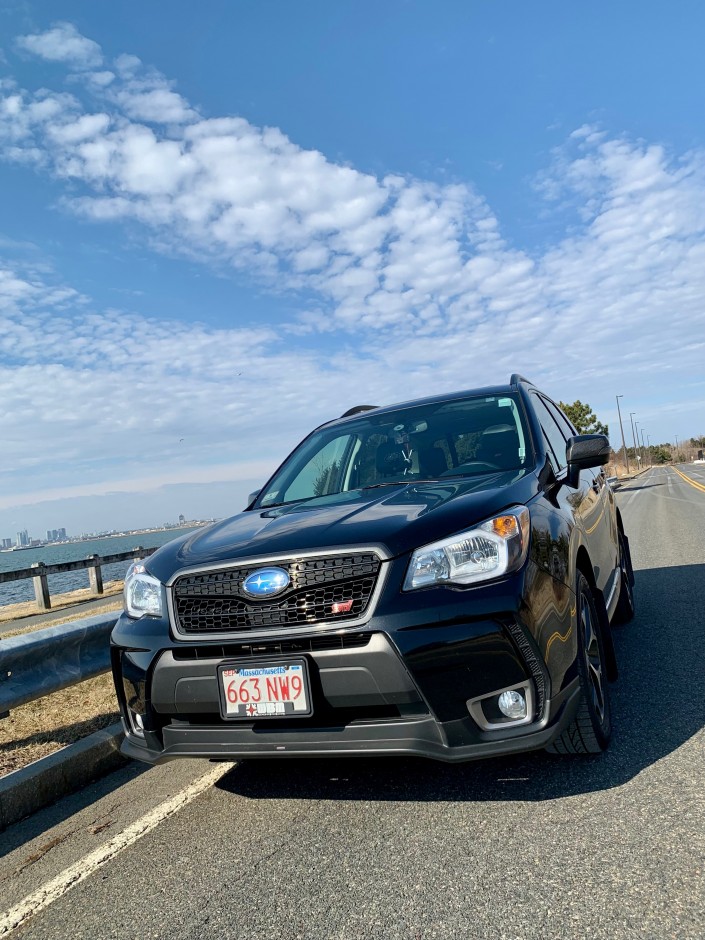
255, 395, 527, 507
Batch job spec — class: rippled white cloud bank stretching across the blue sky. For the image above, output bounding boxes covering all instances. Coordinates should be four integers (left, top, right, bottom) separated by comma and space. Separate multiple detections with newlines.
0, 23, 705, 528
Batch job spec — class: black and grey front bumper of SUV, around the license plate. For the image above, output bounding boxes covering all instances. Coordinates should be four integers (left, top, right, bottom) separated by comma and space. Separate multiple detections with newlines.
112, 564, 579, 763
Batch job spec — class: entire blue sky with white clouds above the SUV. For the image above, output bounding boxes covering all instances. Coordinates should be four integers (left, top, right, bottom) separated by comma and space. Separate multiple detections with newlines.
0, 0, 705, 536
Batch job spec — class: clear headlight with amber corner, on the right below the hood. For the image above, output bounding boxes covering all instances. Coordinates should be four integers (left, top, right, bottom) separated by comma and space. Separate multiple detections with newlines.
403, 506, 530, 591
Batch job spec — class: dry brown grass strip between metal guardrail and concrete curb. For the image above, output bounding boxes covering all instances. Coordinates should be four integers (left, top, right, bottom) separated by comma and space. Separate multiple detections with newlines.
0, 673, 120, 776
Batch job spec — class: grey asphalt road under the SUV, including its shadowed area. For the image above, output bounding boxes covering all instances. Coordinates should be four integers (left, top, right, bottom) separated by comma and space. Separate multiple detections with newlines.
0, 467, 705, 940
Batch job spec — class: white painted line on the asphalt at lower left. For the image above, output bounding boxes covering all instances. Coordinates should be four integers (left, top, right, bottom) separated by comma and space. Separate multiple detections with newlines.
0, 763, 233, 937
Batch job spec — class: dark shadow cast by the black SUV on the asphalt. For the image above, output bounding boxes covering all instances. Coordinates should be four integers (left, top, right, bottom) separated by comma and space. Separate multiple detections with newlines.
217, 565, 705, 802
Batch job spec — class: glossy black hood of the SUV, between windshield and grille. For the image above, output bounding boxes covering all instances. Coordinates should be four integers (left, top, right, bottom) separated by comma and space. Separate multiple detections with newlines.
146, 471, 538, 581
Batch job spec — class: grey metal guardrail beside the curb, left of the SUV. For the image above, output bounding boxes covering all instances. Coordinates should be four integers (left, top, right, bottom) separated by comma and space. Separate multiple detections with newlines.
0, 611, 117, 718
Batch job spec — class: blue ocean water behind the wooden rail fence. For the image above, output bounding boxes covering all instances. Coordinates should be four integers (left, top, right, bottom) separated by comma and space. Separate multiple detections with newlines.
0, 528, 204, 607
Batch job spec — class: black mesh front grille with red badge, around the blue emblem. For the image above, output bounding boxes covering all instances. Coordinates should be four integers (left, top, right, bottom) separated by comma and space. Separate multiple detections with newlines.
172, 552, 381, 635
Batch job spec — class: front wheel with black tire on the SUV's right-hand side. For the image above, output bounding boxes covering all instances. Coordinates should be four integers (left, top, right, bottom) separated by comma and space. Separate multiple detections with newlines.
546, 572, 612, 754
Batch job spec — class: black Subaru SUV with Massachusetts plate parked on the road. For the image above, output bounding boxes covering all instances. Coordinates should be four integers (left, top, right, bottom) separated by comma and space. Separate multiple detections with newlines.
112, 375, 633, 763
